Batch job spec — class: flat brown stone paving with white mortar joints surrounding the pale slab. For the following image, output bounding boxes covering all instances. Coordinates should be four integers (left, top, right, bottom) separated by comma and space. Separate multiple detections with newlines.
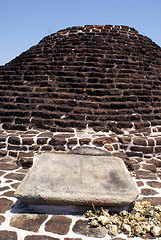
0, 156, 161, 240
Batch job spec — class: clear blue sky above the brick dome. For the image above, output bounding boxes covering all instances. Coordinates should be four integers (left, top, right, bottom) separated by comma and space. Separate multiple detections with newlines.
0, 0, 161, 65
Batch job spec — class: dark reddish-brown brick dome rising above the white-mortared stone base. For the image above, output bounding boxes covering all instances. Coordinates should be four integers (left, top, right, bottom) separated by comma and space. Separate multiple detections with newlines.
0, 25, 161, 133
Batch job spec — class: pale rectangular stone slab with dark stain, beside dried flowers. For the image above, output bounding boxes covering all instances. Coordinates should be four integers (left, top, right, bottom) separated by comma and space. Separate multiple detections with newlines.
15, 153, 138, 206
